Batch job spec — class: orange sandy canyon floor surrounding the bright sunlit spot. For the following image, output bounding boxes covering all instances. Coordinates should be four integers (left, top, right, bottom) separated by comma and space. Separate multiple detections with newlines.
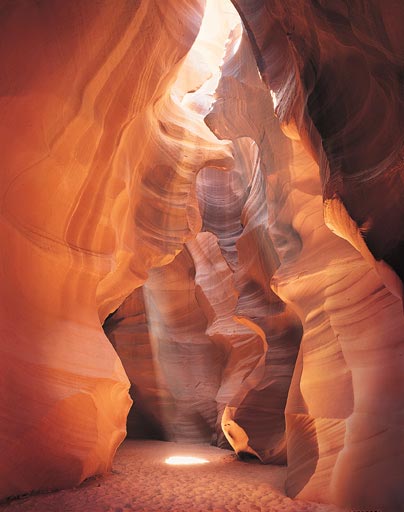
0, 441, 348, 512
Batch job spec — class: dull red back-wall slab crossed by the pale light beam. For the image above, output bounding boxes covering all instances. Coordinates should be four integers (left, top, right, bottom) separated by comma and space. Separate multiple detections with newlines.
145, 250, 223, 442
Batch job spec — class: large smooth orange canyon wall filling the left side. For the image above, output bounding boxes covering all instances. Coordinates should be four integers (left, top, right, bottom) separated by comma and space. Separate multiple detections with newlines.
0, 0, 227, 497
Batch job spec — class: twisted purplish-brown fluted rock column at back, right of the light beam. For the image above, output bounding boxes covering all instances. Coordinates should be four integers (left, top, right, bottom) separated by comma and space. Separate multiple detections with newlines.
194, 142, 301, 463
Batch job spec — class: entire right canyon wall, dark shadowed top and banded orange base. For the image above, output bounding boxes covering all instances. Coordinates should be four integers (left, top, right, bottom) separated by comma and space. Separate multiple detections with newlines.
227, 0, 404, 510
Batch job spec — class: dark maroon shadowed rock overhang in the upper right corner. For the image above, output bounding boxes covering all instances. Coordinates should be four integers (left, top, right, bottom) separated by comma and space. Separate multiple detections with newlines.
234, 0, 404, 278
